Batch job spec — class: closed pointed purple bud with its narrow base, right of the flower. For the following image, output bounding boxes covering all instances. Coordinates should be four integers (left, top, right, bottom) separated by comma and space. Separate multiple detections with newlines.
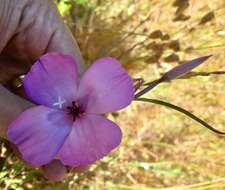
135, 55, 211, 99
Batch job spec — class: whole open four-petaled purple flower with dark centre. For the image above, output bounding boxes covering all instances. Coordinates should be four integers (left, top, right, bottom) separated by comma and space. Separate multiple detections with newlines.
8, 53, 134, 167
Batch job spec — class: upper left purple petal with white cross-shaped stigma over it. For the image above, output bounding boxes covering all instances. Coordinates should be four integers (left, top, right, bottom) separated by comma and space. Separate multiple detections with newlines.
23, 53, 77, 108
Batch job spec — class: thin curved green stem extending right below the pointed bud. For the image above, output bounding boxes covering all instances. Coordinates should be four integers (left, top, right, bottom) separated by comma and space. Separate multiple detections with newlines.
136, 98, 225, 135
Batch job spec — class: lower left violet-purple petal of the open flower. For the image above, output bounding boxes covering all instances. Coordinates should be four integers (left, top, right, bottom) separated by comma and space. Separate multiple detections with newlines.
8, 106, 73, 166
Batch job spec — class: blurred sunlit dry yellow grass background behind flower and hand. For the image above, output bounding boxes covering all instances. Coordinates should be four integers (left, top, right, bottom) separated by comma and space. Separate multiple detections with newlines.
0, 0, 225, 190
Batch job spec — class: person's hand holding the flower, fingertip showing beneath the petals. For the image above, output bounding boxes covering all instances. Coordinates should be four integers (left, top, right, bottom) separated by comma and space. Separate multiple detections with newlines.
0, 0, 84, 180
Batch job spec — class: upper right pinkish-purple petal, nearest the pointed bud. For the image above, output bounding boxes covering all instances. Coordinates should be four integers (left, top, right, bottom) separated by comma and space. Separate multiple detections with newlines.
77, 57, 134, 114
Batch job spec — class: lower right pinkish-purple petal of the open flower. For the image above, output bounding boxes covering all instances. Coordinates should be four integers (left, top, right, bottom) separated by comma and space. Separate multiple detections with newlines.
59, 115, 122, 167
